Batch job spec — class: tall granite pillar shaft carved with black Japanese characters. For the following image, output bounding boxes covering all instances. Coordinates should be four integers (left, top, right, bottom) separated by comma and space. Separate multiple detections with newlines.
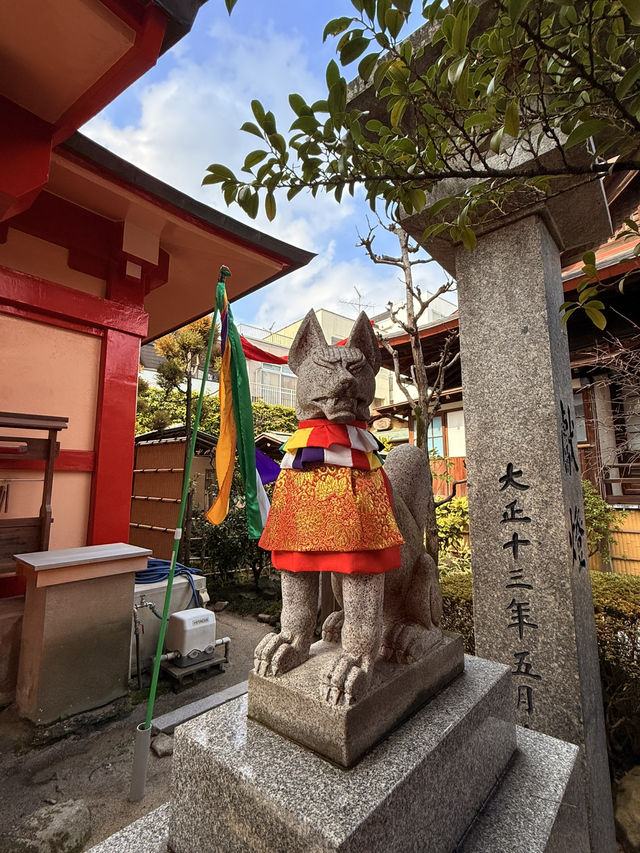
455, 214, 615, 853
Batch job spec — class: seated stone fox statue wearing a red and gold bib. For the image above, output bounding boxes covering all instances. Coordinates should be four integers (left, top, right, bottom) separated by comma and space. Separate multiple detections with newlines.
255, 311, 442, 705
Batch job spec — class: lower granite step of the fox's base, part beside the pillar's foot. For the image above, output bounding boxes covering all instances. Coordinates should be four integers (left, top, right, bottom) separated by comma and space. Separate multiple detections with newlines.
457, 726, 589, 853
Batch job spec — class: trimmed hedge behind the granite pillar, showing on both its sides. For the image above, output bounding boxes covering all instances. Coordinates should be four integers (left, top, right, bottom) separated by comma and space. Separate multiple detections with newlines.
440, 571, 640, 777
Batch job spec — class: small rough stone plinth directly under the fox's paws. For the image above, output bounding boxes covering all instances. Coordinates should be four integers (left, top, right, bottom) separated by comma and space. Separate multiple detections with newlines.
248, 635, 464, 767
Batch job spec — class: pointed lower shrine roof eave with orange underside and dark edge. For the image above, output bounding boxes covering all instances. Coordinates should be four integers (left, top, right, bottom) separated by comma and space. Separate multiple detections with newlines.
53, 133, 315, 341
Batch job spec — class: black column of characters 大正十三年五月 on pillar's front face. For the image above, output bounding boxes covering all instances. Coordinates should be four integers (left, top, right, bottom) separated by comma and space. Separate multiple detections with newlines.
498, 462, 542, 714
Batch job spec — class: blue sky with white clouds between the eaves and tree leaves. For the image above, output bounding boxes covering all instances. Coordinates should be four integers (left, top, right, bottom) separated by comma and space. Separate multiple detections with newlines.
83, 0, 450, 328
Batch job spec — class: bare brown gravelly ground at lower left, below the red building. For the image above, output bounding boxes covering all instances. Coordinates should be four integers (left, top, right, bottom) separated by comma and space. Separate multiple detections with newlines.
0, 612, 271, 849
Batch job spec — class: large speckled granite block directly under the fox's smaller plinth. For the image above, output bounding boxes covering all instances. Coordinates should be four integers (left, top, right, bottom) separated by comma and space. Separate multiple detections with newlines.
169, 657, 515, 853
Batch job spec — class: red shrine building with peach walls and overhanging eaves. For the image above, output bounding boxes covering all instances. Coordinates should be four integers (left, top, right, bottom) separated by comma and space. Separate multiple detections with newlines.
0, 0, 312, 722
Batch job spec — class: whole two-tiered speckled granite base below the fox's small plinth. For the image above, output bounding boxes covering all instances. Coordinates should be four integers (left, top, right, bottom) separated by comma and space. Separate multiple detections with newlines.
89, 658, 589, 853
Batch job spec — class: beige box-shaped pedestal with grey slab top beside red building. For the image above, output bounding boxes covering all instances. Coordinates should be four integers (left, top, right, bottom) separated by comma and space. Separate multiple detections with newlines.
16, 542, 151, 725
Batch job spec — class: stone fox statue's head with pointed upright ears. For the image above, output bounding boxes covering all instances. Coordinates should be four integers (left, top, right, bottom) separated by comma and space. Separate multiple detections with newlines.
289, 311, 380, 424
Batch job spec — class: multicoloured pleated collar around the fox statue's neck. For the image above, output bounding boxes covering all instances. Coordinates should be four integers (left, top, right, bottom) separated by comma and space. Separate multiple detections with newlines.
280, 418, 383, 471
